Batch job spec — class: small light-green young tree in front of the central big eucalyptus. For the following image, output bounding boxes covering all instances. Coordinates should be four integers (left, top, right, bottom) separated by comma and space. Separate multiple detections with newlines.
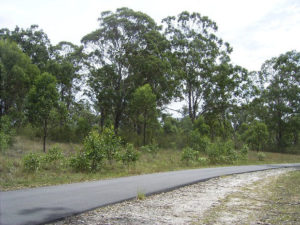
130, 84, 157, 145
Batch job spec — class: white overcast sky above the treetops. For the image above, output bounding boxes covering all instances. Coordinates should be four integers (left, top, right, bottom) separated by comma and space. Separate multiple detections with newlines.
0, 0, 300, 114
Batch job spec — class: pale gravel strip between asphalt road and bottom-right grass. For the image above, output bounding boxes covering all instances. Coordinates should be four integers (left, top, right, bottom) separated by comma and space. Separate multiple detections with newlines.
53, 169, 292, 225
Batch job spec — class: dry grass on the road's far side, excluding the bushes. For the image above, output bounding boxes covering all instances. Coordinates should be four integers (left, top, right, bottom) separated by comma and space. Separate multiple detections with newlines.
0, 136, 300, 190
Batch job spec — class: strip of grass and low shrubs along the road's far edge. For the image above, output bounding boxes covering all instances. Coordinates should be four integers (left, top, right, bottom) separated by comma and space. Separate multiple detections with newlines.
0, 133, 300, 191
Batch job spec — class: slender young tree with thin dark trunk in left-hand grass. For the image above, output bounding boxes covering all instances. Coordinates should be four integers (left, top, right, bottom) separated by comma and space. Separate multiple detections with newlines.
27, 72, 58, 152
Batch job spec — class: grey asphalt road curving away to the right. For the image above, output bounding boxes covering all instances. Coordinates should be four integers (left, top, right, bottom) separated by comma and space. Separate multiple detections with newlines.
0, 163, 300, 225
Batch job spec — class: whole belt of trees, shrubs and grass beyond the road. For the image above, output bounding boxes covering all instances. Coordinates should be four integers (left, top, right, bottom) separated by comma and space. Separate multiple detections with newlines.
0, 8, 300, 189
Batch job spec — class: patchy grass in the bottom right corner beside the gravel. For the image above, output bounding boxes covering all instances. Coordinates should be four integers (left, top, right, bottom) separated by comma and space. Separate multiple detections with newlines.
195, 170, 300, 225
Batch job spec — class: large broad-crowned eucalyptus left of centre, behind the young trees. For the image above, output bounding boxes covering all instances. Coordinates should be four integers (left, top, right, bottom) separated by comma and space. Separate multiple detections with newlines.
82, 8, 174, 131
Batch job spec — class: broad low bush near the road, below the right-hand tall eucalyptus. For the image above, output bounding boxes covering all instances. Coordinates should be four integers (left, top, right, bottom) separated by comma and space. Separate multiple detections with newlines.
206, 141, 238, 164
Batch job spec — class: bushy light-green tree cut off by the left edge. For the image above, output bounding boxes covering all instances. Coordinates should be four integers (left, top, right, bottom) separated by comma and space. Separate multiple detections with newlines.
0, 40, 40, 122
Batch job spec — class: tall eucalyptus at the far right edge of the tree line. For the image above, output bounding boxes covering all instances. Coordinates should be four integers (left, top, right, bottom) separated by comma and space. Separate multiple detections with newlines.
260, 51, 300, 150
